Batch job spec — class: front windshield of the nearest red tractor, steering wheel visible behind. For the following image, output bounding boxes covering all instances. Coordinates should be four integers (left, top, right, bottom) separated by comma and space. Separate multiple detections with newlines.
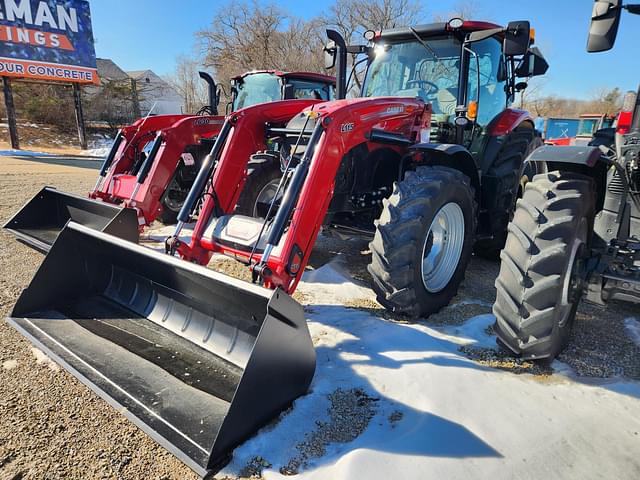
362, 37, 461, 115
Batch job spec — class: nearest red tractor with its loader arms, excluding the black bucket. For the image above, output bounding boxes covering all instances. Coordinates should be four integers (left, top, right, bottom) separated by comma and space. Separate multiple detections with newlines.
168, 22, 547, 316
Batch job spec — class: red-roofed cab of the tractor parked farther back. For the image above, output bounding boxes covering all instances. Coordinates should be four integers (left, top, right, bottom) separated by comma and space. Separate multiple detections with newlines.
227, 70, 335, 112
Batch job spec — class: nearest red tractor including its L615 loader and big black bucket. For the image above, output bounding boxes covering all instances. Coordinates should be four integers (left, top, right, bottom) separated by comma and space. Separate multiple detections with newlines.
10, 19, 548, 475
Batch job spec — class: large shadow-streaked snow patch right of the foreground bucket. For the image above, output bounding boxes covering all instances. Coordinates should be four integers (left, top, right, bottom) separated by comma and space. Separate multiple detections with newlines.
216, 270, 640, 480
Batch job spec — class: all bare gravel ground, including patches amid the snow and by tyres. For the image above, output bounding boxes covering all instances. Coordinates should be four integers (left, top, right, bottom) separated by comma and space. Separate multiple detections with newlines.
0, 157, 640, 480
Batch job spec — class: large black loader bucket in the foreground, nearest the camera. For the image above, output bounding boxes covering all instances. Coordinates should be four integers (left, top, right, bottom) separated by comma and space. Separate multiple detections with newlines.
9, 223, 315, 475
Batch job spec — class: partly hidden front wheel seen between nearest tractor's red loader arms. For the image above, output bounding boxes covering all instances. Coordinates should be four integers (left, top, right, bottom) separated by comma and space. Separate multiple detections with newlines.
236, 162, 282, 218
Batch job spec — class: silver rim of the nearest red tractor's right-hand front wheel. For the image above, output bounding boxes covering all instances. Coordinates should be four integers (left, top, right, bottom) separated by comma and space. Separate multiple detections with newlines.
421, 202, 464, 293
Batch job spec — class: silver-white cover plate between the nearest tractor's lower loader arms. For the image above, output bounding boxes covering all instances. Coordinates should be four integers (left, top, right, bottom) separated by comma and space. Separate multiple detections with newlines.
202, 215, 272, 253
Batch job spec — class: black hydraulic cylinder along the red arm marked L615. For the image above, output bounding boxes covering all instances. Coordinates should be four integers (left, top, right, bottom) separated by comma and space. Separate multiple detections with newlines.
260, 122, 324, 267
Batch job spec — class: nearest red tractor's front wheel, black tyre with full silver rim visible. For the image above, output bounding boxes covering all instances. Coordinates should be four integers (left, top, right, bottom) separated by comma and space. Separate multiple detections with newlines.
368, 166, 477, 317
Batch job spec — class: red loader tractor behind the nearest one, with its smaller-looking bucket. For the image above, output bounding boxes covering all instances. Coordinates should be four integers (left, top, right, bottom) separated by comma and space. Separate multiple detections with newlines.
5, 70, 335, 251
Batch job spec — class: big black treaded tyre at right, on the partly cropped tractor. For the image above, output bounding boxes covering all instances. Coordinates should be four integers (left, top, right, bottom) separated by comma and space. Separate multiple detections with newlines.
493, 171, 596, 360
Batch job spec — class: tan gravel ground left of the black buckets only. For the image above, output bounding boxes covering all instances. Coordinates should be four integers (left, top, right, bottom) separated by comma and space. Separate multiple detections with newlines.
0, 157, 197, 480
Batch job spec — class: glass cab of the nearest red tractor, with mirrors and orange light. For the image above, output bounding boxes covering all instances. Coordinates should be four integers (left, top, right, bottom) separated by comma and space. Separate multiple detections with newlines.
356, 18, 548, 152
